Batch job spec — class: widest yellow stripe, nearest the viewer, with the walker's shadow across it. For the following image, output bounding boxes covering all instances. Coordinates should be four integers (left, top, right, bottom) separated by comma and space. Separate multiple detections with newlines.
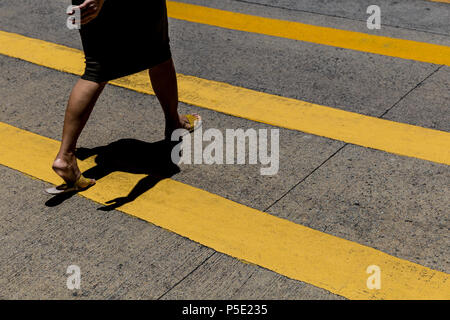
0, 122, 450, 299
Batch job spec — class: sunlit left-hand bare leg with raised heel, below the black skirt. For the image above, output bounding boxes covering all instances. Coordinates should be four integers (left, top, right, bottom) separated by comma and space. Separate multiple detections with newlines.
53, 79, 106, 184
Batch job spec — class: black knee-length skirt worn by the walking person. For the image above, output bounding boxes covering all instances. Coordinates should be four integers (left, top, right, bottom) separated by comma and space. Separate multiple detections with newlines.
72, 0, 171, 82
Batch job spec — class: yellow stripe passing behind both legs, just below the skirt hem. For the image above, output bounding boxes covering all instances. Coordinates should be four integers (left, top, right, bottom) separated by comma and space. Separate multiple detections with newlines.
0, 31, 450, 165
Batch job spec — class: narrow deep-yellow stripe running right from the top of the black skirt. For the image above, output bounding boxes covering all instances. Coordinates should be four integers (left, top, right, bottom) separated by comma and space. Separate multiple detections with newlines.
167, 1, 450, 66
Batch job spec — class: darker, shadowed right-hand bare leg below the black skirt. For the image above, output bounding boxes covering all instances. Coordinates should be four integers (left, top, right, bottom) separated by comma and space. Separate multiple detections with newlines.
149, 59, 196, 137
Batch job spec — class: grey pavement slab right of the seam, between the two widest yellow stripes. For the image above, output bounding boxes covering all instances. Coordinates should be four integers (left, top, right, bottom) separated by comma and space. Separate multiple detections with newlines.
268, 145, 450, 273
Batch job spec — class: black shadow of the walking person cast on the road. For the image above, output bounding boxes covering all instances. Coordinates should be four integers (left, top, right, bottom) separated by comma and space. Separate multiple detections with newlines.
45, 139, 180, 211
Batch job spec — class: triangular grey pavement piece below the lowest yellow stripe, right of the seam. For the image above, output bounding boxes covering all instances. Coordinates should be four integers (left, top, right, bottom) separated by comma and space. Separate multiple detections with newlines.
163, 253, 343, 300
